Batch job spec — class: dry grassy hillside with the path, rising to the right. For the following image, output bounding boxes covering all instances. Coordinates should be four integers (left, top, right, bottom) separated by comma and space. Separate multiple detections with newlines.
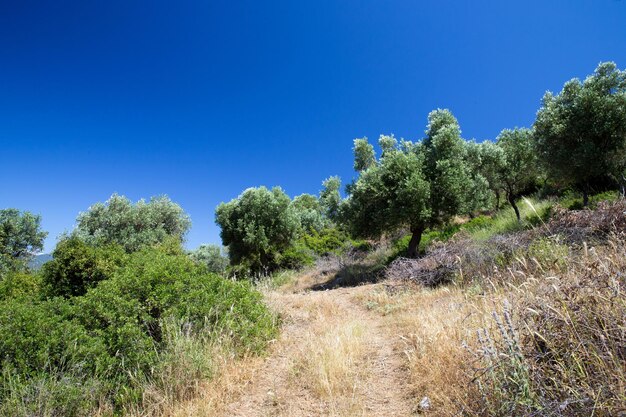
166, 198, 626, 416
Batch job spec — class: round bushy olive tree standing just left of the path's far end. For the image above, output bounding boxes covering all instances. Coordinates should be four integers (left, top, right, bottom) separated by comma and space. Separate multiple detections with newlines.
215, 187, 301, 273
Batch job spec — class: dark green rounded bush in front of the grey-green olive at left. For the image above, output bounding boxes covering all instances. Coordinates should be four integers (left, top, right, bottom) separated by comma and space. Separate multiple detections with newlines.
41, 236, 127, 297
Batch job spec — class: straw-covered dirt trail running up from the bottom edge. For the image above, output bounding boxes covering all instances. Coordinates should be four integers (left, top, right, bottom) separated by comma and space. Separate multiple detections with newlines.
212, 285, 415, 417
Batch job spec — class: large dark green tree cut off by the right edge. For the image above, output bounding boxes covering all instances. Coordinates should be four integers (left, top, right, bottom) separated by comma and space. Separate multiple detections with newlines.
534, 62, 626, 206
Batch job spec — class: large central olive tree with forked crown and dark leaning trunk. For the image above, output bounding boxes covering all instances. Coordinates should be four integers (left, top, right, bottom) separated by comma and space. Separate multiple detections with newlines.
345, 110, 476, 257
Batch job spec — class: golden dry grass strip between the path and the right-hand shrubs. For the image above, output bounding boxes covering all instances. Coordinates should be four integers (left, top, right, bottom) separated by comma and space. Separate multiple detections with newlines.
356, 286, 488, 416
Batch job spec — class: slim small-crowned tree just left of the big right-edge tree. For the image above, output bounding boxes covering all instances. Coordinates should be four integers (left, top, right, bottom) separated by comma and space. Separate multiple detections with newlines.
496, 128, 539, 222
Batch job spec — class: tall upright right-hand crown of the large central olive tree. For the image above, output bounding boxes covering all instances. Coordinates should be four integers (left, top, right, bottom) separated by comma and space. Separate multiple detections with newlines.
422, 109, 473, 225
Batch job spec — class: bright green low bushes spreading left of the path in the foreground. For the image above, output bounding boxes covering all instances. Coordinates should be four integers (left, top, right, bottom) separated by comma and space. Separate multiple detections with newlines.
0, 239, 276, 415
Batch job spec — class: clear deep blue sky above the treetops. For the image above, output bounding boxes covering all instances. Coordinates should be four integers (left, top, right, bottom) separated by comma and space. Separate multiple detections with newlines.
0, 0, 626, 251
